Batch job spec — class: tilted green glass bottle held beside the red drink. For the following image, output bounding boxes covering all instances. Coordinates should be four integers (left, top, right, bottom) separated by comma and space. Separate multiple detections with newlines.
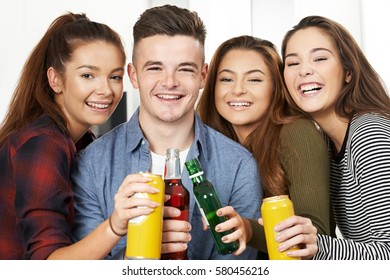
185, 158, 239, 255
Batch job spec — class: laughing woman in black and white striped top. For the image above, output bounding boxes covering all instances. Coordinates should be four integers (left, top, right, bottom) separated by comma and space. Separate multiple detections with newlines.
282, 16, 390, 259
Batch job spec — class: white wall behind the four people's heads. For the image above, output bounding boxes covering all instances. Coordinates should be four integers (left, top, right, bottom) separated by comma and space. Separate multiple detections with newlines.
0, 0, 390, 121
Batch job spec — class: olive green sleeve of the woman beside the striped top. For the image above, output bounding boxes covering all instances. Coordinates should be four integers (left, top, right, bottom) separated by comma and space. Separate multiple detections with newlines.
280, 120, 335, 236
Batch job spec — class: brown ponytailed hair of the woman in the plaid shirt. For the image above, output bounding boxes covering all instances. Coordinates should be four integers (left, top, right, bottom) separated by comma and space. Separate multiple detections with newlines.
0, 13, 126, 145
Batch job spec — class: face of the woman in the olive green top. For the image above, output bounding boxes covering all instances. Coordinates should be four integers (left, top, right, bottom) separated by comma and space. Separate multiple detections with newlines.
215, 50, 273, 142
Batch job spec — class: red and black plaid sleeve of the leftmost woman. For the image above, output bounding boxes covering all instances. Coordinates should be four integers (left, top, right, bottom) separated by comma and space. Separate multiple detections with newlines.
13, 131, 74, 259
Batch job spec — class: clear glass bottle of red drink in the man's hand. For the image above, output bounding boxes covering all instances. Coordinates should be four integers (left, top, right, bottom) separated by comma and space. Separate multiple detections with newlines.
161, 148, 190, 260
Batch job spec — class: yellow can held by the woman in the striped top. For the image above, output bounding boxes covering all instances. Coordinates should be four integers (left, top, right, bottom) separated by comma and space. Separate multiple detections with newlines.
261, 195, 300, 260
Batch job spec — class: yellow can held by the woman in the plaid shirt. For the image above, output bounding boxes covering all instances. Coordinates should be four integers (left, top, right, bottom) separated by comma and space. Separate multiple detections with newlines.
126, 173, 165, 260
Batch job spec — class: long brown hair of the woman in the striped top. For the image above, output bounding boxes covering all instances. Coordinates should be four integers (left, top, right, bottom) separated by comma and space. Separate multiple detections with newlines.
281, 16, 390, 120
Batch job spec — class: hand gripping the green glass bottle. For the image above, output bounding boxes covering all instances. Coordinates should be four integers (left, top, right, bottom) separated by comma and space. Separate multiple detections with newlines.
215, 206, 252, 256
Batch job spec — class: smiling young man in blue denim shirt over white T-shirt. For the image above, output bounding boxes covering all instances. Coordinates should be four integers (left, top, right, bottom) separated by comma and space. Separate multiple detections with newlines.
73, 5, 262, 259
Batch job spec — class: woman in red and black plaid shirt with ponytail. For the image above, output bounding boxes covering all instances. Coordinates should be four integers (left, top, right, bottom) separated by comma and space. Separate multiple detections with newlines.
0, 13, 158, 259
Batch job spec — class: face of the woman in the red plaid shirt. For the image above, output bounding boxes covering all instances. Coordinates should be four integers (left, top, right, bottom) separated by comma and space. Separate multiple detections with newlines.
56, 41, 124, 137
